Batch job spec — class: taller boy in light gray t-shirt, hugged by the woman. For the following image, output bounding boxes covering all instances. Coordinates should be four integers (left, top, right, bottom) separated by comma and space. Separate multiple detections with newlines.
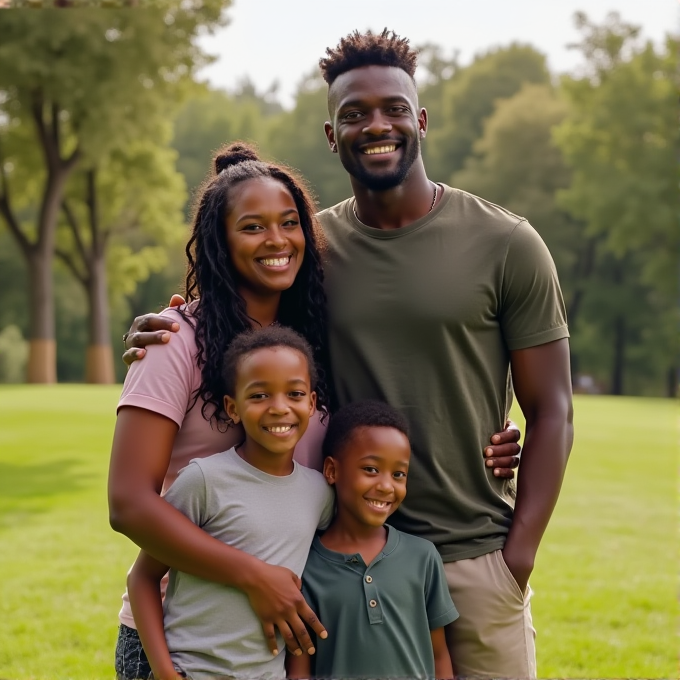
128, 326, 333, 680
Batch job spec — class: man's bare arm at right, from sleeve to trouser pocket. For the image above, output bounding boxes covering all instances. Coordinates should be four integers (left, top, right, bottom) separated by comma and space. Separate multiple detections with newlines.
503, 338, 574, 591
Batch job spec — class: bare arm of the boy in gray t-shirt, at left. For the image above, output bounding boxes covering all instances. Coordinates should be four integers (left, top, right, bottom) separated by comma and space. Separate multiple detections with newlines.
127, 550, 179, 680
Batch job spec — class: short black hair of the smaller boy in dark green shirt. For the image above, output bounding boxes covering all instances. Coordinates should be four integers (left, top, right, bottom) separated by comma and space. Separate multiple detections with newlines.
322, 400, 408, 458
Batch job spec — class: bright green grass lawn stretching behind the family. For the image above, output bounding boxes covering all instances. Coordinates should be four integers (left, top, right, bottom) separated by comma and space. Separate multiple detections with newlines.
0, 385, 678, 680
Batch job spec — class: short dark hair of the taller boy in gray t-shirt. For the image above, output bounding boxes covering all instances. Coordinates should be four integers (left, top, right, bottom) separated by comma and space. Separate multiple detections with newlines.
222, 325, 318, 397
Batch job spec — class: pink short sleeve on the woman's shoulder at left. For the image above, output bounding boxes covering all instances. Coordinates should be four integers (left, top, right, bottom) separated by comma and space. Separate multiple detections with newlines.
118, 309, 196, 427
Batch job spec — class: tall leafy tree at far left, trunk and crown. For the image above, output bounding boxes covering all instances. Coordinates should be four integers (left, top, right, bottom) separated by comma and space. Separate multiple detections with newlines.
0, 0, 225, 382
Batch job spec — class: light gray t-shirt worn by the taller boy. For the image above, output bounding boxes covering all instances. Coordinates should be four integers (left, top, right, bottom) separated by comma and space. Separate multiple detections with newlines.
163, 449, 334, 680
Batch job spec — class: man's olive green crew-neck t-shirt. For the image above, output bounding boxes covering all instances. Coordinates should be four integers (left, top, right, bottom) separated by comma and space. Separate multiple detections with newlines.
319, 187, 569, 561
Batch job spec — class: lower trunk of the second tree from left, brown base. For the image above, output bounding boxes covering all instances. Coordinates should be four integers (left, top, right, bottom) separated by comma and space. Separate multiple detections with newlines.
85, 255, 116, 385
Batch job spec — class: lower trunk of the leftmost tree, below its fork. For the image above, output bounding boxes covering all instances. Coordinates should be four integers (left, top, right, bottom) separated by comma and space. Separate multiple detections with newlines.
26, 248, 57, 384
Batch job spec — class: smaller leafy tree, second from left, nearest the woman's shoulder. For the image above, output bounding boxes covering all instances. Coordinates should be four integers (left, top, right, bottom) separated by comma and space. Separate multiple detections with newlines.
56, 135, 186, 384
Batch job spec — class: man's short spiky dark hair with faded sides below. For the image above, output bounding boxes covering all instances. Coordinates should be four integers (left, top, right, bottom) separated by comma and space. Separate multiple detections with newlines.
319, 28, 418, 86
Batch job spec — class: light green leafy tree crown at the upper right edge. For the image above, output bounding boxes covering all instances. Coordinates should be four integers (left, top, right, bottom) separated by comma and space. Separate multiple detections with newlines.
555, 25, 680, 296
